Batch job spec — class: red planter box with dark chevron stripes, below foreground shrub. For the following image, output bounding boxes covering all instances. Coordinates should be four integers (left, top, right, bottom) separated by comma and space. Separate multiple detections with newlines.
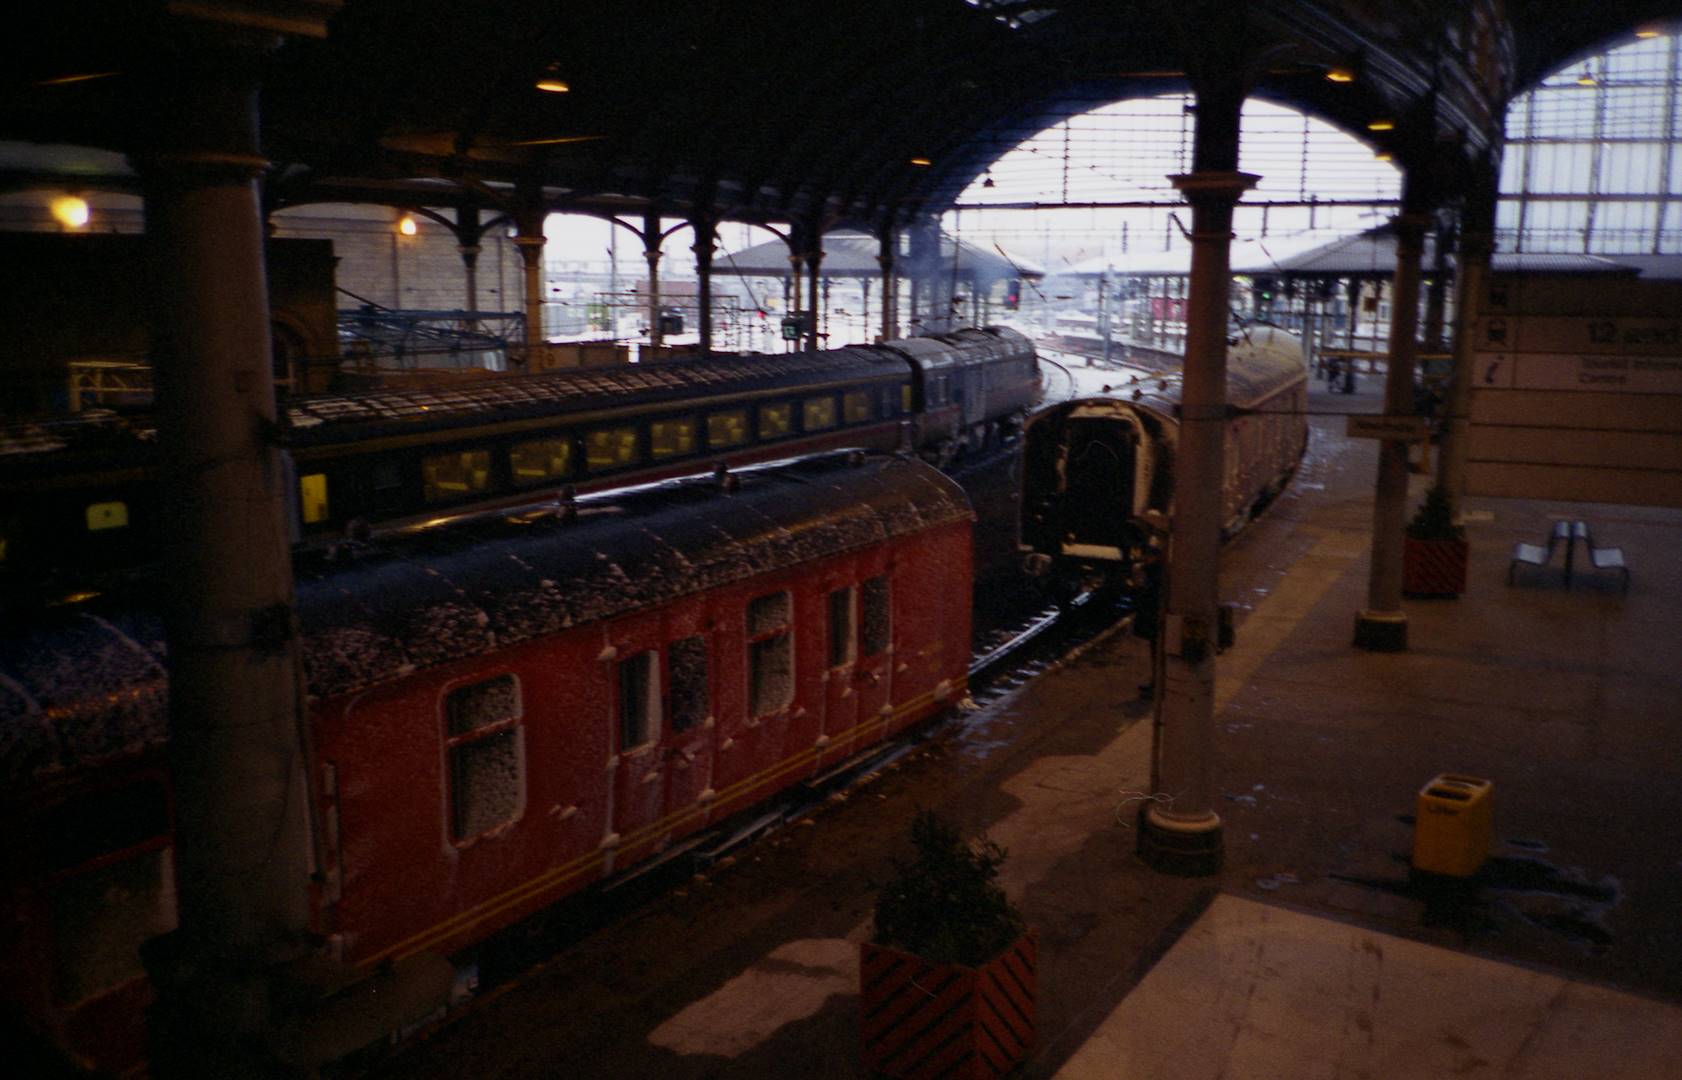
860, 930, 1038, 1080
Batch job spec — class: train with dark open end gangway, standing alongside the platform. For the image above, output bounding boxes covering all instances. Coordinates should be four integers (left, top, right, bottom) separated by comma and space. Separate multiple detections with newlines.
1021, 325, 1309, 592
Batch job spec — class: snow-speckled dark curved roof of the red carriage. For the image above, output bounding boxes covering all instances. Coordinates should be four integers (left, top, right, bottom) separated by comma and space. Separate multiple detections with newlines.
0, 453, 972, 781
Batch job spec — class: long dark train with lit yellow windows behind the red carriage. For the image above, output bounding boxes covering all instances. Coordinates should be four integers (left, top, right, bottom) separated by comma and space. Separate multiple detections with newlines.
0, 328, 1039, 587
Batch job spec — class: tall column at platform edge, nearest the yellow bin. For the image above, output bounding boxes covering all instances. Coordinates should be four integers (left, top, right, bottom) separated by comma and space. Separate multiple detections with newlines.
1139, 71, 1258, 875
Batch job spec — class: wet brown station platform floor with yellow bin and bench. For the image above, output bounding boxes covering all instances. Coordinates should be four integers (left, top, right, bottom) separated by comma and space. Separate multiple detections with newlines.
375, 379, 1682, 1080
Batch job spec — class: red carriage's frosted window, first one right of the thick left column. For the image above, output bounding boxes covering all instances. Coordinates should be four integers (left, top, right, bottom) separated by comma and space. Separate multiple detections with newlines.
444, 675, 525, 841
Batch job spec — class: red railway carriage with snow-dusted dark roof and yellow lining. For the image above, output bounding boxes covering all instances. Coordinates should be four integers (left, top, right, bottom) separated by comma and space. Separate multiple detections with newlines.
0, 454, 972, 1065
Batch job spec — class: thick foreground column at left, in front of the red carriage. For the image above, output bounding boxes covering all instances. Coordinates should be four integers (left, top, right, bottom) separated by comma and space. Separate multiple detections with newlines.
135, 18, 313, 1077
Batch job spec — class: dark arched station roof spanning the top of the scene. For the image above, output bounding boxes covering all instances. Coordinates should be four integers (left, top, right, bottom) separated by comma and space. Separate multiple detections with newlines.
0, 0, 1677, 230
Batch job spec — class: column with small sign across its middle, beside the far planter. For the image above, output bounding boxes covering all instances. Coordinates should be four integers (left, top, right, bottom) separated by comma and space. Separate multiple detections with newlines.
1356, 199, 1431, 653
